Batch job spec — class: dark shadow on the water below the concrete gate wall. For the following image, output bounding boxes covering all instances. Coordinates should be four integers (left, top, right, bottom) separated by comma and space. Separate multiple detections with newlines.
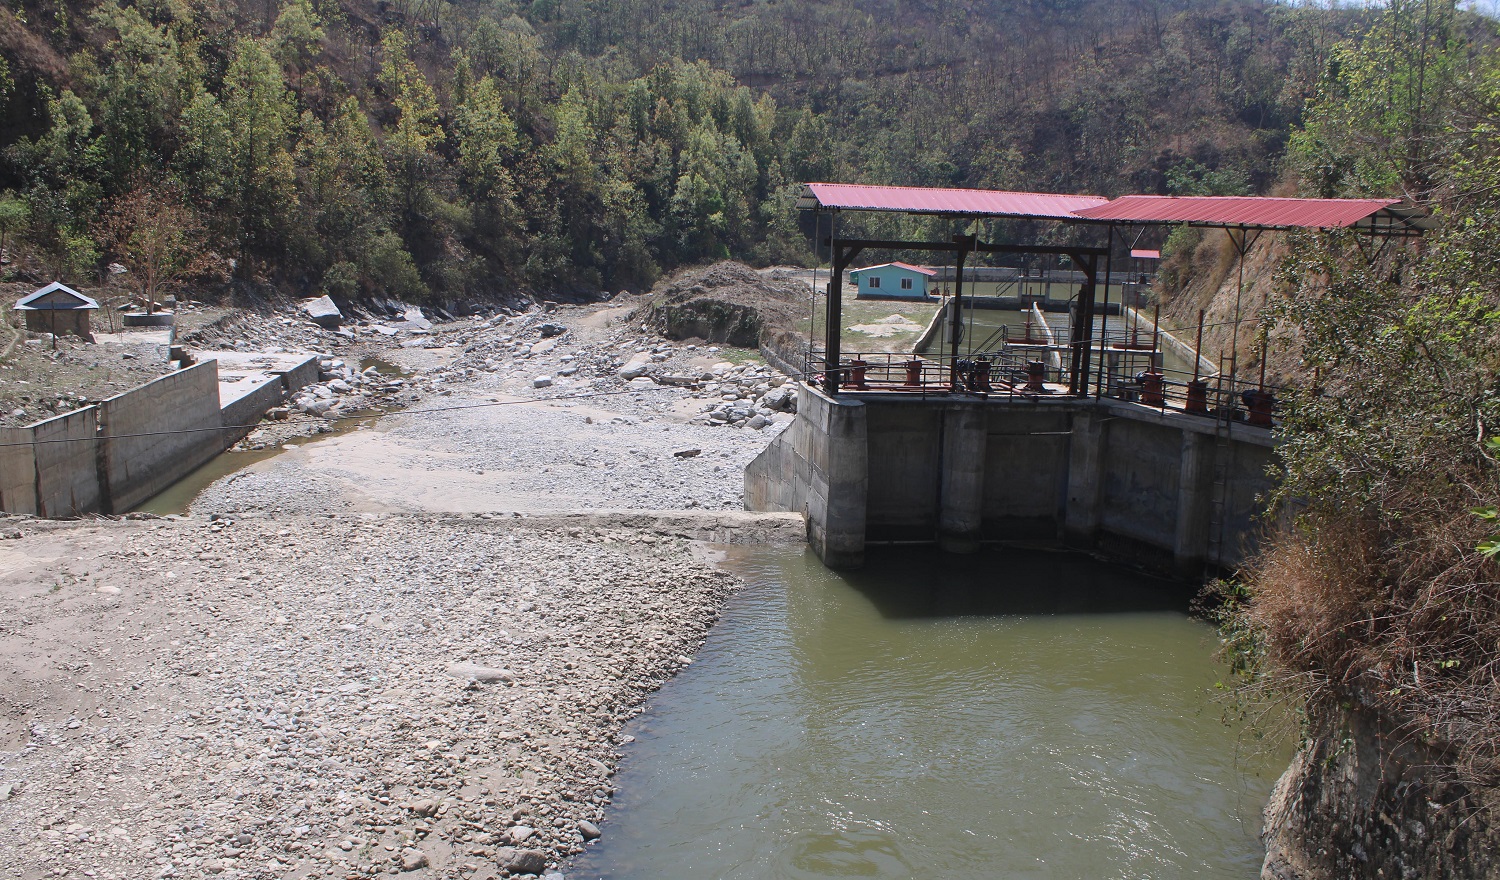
840, 546, 1194, 621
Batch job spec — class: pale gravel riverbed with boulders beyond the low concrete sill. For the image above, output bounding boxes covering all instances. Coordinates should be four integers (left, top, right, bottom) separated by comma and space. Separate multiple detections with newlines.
192, 299, 795, 516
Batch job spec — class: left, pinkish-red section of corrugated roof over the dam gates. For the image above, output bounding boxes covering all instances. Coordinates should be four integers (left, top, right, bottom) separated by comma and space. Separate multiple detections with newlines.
797, 183, 1109, 220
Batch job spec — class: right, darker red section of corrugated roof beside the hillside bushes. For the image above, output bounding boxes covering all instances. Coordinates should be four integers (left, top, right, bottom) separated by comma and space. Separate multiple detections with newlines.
1076, 195, 1401, 229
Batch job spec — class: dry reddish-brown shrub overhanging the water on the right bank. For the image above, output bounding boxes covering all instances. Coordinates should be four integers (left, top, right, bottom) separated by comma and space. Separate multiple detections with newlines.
1242, 492, 1500, 784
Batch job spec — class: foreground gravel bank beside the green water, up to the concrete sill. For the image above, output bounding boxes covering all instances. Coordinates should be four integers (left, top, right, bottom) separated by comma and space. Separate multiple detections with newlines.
0, 513, 801, 880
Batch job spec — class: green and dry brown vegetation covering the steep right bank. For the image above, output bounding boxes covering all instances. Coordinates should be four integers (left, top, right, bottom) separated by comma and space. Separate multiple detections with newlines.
1218, 0, 1500, 815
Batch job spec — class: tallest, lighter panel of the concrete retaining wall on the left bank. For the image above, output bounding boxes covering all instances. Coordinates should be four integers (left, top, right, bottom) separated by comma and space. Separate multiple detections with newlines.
99, 361, 224, 513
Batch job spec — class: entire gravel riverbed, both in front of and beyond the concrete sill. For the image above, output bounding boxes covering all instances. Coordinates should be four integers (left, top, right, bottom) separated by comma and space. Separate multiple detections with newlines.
0, 292, 803, 880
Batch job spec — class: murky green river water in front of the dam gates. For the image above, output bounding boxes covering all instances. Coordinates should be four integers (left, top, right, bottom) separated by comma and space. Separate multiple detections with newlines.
567, 547, 1290, 880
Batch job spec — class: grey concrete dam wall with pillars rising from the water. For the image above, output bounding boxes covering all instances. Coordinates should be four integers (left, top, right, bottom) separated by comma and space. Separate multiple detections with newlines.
746, 384, 1274, 577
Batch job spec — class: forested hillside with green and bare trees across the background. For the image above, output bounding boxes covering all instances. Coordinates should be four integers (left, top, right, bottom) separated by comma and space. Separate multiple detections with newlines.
0, 0, 1361, 300
